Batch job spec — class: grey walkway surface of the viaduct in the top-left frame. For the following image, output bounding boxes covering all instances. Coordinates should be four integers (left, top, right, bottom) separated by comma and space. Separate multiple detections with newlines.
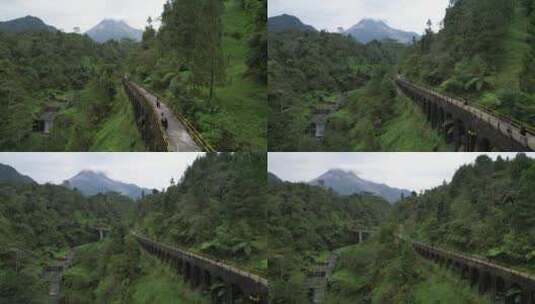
129, 81, 202, 152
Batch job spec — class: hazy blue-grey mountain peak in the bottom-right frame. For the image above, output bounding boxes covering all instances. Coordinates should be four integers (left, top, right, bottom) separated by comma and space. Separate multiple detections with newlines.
309, 169, 411, 203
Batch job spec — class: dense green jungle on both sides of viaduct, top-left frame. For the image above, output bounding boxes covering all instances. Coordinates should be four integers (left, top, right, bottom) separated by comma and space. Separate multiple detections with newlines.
0, 0, 267, 151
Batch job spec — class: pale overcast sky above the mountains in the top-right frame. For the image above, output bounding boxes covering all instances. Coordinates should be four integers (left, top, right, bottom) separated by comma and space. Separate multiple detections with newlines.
268, 0, 449, 33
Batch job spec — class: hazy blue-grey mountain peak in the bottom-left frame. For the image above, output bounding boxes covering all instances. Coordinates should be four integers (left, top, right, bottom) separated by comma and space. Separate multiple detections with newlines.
63, 170, 151, 199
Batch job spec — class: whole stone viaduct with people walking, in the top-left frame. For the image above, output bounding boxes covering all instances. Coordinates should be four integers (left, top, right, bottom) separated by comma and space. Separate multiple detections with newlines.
123, 77, 215, 152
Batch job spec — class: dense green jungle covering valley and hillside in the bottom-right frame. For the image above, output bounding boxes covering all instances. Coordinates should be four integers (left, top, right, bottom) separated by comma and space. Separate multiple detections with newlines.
268, 153, 535, 304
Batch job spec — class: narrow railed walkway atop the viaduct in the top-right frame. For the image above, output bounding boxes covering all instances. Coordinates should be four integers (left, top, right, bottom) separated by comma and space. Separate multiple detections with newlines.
396, 76, 535, 151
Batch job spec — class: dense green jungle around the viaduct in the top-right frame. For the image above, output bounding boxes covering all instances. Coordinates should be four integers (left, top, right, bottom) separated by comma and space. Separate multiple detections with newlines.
268, 0, 535, 151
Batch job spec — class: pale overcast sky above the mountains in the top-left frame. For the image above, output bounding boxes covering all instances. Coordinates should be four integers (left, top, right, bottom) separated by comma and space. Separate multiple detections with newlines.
0, 0, 166, 32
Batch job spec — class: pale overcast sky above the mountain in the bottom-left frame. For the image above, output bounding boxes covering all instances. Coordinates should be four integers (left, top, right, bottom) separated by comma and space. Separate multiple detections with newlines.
0, 152, 202, 189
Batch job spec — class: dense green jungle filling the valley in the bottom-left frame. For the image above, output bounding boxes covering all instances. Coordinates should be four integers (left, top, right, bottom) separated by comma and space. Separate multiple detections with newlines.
0, 153, 267, 304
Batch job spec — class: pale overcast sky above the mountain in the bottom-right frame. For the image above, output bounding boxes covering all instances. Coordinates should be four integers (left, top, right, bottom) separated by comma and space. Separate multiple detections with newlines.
268, 153, 535, 192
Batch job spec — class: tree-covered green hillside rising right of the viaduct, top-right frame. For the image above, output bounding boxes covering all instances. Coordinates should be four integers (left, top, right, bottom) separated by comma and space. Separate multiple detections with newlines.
401, 0, 535, 124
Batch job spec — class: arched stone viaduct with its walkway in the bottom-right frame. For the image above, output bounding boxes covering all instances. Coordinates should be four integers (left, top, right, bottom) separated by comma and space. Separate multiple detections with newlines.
412, 241, 535, 304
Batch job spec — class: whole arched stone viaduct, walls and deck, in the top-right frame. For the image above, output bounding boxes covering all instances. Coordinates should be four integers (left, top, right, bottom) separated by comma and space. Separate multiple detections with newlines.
395, 76, 535, 152
